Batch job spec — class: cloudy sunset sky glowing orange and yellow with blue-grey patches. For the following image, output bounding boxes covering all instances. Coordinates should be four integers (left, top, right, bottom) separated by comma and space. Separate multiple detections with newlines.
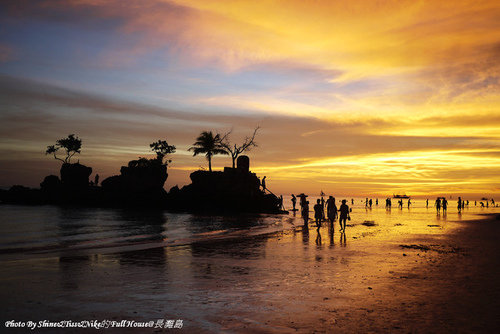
0, 0, 500, 199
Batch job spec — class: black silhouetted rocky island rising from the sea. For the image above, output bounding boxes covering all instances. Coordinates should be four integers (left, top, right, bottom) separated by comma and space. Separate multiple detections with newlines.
0, 133, 283, 213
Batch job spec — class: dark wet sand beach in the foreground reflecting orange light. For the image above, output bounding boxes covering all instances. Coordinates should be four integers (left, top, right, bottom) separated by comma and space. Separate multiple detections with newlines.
0, 215, 500, 333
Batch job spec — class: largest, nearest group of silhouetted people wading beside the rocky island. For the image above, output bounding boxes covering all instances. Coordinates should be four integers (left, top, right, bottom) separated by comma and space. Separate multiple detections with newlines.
292, 194, 351, 232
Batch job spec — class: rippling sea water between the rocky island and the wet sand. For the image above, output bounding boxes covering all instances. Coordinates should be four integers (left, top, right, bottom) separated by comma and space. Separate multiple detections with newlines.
0, 197, 500, 257
